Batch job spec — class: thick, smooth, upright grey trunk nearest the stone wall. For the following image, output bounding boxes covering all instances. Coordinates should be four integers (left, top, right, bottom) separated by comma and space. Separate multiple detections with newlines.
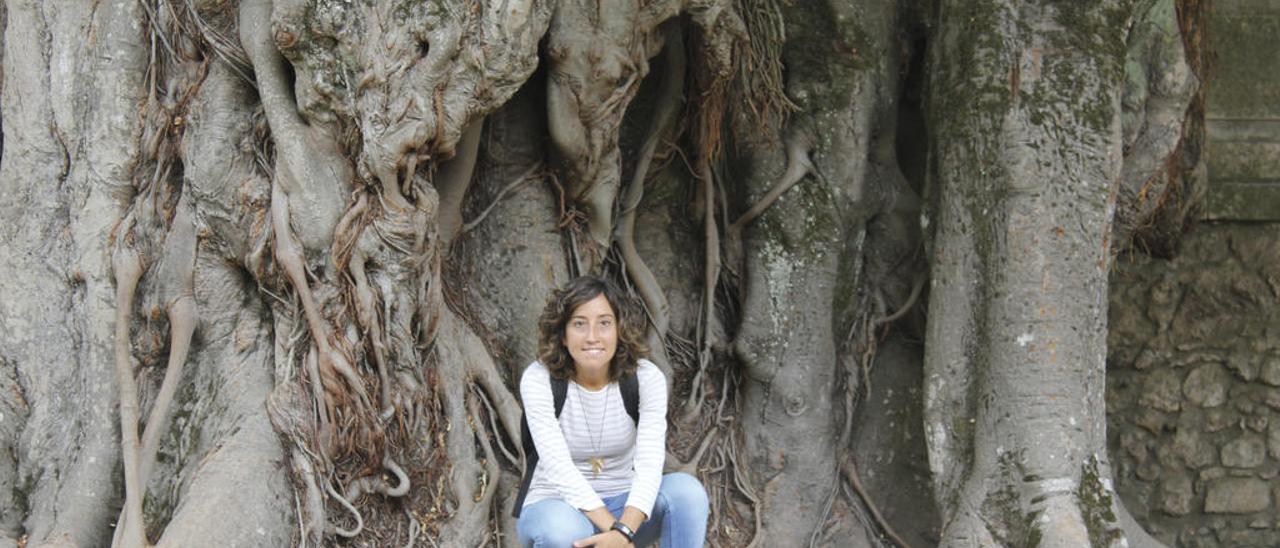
925, 1, 1185, 547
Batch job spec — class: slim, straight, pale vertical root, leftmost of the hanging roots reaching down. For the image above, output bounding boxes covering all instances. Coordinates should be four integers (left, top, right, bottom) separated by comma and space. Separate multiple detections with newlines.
111, 231, 146, 548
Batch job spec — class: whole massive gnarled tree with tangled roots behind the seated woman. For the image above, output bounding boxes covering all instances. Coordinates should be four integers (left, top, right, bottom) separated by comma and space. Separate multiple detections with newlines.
0, 0, 1196, 547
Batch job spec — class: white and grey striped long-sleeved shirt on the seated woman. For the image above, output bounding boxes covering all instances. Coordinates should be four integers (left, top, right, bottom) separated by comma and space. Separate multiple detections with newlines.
520, 360, 667, 516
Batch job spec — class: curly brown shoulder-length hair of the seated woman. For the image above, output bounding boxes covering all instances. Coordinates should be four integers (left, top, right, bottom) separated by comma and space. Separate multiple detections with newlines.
538, 275, 649, 382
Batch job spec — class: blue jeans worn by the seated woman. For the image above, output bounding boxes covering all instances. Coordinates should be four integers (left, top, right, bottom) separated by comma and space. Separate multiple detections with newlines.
516, 472, 710, 548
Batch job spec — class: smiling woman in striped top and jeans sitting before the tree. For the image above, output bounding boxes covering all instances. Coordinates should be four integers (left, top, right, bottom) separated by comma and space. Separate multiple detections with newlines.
516, 277, 708, 548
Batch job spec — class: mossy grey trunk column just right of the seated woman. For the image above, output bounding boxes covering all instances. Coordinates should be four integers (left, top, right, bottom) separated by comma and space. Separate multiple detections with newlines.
736, 3, 897, 545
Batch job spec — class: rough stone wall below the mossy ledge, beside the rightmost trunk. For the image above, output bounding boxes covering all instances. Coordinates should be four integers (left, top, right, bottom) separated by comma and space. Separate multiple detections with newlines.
1107, 223, 1280, 547
